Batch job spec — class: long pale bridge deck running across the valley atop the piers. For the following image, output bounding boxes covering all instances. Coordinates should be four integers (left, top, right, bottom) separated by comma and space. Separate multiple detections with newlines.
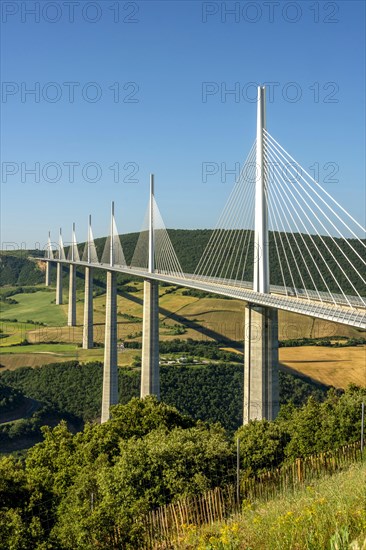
40, 258, 366, 330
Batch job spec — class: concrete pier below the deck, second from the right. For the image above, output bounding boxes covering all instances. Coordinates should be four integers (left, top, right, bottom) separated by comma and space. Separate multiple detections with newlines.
140, 280, 160, 399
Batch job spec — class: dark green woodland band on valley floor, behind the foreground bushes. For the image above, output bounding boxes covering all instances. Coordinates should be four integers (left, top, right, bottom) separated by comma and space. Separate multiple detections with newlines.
0, 361, 326, 431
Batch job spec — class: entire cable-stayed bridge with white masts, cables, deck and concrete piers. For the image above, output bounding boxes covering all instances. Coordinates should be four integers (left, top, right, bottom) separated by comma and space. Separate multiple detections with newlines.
42, 87, 366, 422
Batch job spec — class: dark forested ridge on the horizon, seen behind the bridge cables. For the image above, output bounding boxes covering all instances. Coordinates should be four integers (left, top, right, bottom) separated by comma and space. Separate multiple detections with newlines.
0, 229, 365, 295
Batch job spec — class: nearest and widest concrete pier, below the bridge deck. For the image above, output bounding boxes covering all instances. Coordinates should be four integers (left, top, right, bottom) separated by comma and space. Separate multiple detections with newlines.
243, 304, 279, 424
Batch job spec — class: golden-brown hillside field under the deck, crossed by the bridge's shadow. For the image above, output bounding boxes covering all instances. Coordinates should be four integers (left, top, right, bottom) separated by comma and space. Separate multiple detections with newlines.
28, 284, 359, 342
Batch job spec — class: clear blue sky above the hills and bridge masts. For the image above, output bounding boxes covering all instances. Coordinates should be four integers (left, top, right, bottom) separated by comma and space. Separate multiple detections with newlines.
1, 0, 365, 248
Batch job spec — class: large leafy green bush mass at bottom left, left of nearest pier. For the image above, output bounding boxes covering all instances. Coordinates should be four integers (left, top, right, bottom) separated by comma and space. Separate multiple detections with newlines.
0, 397, 233, 550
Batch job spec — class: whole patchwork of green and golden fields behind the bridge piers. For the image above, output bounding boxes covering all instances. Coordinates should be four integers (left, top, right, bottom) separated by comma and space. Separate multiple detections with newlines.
0, 282, 366, 388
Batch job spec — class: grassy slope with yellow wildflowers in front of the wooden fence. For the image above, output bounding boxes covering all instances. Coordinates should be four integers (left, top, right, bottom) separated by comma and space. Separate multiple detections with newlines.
177, 463, 366, 550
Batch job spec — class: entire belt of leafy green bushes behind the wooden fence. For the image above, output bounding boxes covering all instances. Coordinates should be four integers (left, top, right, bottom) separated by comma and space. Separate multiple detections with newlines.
0, 387, 366, 550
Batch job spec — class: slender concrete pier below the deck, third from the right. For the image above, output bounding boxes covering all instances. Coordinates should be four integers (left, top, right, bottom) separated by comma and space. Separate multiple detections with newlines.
101, 271, 118, 424
